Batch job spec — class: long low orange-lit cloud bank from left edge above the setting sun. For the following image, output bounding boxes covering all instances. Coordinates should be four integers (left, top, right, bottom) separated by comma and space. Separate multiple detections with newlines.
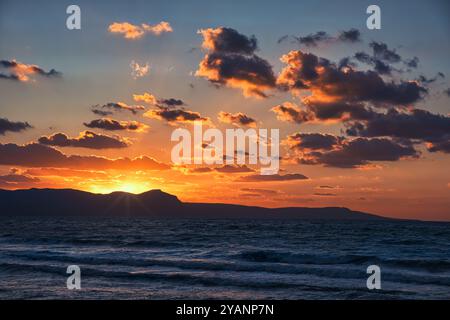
0, 143, 170, 170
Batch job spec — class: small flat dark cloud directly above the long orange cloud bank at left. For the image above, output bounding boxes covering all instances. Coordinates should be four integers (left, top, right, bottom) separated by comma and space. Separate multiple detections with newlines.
38, 131, 128, 149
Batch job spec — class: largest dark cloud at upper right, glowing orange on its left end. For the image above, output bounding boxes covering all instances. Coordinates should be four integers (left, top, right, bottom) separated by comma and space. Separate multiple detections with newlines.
277, 51, 428, 105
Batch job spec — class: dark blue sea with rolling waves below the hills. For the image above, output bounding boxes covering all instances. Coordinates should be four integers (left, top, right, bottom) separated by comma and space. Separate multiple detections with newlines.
0, 218, 450, 299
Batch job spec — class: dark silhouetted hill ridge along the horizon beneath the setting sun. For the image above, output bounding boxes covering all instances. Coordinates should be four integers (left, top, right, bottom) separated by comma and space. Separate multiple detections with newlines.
0, 189, 386, 220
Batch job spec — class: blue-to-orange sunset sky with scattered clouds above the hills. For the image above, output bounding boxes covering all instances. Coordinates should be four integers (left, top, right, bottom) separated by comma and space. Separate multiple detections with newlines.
0, 0, 450, 220
